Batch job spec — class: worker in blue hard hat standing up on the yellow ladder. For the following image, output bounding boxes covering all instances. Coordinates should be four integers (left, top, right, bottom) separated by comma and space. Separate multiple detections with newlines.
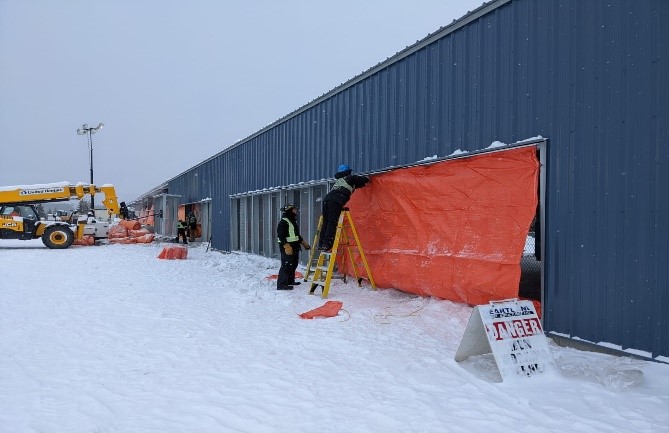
318, 164, 370, 252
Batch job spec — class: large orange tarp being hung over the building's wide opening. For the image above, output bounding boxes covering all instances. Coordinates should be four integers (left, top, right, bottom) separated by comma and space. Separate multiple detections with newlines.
348, 146, 539, 305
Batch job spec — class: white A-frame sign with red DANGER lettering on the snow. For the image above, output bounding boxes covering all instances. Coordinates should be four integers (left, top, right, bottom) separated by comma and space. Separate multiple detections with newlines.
455, 299, 555, 379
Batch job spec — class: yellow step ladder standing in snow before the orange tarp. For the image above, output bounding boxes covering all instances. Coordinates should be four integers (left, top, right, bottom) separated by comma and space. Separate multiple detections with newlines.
304, 207, 376, 298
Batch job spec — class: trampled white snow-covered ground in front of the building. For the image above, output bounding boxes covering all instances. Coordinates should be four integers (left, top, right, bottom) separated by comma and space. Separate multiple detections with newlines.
0, 240, 669, 433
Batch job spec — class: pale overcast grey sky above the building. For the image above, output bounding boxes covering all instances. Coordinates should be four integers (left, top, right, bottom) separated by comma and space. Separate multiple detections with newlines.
0, 0, 483, 201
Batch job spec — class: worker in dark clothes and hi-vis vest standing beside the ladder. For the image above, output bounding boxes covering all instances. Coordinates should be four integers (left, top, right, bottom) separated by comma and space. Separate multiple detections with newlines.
276, 204, 311, 290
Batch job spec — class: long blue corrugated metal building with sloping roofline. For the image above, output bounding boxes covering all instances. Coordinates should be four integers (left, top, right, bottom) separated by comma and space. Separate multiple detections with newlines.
137, 0, 669, 357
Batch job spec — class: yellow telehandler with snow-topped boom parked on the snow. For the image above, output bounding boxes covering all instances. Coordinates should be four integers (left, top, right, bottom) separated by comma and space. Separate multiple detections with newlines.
0, 182, 119, 249
